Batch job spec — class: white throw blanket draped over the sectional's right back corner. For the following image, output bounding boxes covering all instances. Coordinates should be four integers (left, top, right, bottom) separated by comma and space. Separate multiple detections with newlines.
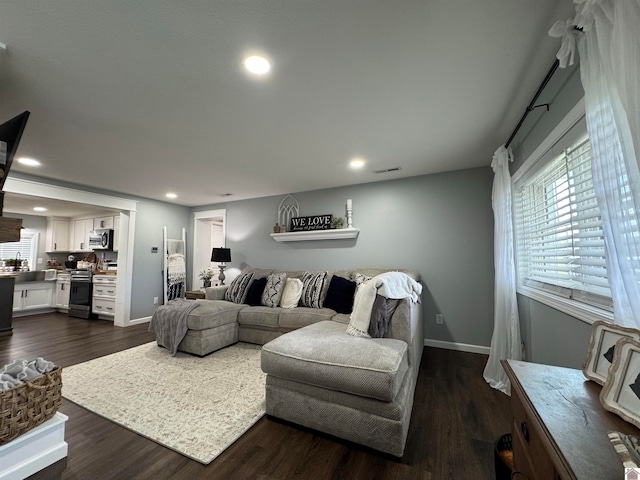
347, 272, 422, 337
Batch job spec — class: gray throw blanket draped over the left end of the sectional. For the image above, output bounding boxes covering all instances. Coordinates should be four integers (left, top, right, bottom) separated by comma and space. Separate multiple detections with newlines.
149, 298, 200, 356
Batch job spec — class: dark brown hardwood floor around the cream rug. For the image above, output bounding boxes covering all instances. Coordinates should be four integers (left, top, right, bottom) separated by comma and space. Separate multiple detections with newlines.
0, 313, 511, 480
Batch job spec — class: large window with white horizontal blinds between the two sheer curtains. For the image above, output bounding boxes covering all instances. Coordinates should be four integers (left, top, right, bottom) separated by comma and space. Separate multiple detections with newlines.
514, 115, 613, 311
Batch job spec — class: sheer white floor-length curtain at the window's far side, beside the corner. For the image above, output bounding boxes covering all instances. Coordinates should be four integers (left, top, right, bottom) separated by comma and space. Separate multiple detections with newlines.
484, 145, 522, 395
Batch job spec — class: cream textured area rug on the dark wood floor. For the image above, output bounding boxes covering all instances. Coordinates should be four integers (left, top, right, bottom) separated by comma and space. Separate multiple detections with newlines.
62, 342, 266, 464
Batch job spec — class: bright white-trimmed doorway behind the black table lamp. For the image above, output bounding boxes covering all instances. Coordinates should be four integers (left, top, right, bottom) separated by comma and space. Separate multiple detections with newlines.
191, 209, 227, 290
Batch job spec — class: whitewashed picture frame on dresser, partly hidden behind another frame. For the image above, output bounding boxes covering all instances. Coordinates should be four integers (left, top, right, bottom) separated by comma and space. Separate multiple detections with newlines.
582, 320, 640, 385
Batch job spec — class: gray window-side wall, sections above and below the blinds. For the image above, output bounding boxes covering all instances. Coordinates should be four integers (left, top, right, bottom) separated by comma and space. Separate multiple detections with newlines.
504, 60, 591, 368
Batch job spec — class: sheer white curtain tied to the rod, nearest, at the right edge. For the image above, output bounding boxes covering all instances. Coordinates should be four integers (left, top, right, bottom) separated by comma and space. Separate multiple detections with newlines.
549, 0, 640, 328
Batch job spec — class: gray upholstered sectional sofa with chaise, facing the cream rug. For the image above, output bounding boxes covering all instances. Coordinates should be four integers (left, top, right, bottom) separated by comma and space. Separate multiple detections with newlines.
172, 268, 424, 457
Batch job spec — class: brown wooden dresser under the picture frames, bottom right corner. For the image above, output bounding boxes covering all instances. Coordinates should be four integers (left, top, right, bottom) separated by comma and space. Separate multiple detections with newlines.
502, 360, 640, 480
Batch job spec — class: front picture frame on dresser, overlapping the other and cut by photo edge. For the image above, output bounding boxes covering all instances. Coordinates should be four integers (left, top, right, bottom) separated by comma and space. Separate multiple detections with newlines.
600, 338, 640, 427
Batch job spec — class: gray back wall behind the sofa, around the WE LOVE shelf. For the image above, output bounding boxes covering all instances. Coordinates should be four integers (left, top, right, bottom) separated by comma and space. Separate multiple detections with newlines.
190, 168, 493, 346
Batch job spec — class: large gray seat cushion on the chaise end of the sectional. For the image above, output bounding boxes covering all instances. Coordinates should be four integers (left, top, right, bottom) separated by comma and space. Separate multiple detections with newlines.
261, 321, 408, 402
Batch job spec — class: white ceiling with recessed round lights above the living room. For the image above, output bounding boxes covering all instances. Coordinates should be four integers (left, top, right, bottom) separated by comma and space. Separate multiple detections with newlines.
0, 0, 573, 206
